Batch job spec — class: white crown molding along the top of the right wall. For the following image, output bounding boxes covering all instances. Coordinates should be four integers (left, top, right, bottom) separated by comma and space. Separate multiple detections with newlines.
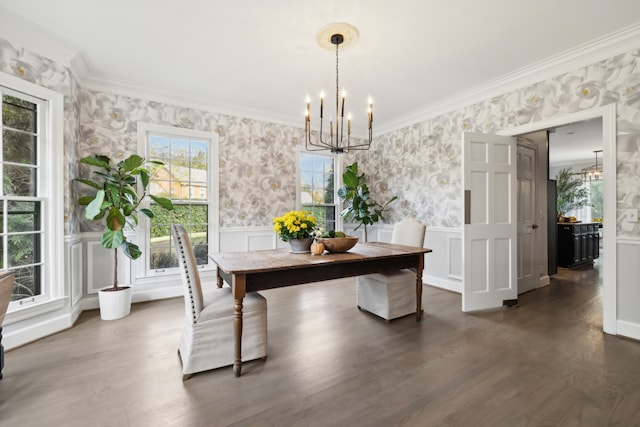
378, 23, 640, 135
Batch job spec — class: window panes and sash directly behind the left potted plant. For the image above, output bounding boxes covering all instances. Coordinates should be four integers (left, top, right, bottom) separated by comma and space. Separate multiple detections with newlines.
139, 123, 218, 274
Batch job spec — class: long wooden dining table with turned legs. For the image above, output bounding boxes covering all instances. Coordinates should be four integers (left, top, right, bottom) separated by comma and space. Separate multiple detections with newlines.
209, 243, 431, 377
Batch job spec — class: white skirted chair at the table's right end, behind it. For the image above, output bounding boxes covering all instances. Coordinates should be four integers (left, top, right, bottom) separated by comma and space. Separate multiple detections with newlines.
356, 219, 427, 323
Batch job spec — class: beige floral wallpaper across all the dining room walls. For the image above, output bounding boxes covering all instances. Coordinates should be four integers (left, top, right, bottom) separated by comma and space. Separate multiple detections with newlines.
0, 39, 640, 238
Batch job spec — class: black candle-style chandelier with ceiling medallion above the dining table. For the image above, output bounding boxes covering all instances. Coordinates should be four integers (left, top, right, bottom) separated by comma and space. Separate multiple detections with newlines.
304, 23, 373, 153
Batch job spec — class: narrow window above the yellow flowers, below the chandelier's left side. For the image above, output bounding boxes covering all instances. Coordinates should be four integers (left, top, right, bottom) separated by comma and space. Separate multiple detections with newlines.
300, 152, 338, 231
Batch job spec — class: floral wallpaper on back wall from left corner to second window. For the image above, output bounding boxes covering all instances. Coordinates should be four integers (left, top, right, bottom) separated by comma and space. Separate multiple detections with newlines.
79, 90, 304, 230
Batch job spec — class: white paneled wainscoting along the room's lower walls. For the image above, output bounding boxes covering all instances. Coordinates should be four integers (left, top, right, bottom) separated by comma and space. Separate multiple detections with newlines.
3, 224, 640, 350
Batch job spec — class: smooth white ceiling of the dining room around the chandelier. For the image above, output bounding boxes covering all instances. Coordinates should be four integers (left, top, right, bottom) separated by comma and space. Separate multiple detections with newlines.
0, 0, 640, 137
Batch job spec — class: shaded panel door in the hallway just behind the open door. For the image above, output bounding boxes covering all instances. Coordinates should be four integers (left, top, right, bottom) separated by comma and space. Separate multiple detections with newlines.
516, 141, 538, 294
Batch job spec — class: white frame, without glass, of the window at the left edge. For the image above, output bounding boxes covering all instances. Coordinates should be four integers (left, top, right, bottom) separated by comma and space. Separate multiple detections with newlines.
0, 72, 68, 316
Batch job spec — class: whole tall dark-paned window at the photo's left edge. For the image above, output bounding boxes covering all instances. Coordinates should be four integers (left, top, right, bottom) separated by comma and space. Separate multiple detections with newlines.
0, 76, 64, 311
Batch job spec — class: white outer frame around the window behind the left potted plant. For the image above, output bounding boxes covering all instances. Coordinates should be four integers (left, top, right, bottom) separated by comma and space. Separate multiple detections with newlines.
134, 122, 220, 279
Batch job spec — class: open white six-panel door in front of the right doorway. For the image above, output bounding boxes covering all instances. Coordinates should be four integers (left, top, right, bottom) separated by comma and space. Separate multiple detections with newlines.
462, 132, 518, 311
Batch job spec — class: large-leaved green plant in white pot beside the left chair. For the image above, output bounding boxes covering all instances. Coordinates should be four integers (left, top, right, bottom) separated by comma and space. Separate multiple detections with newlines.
76, 154, 173, 320
